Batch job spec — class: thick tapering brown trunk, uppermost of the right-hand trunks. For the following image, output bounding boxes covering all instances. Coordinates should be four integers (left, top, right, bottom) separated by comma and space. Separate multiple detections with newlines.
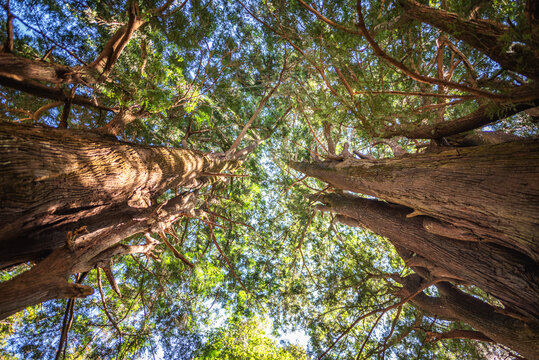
291, 139, 539, 261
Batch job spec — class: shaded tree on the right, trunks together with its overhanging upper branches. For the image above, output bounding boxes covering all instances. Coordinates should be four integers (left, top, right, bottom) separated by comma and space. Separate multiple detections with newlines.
266, 1, 539, 358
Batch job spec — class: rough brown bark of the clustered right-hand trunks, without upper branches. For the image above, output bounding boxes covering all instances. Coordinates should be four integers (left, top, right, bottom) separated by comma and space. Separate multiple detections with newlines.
300, 136, 539, 359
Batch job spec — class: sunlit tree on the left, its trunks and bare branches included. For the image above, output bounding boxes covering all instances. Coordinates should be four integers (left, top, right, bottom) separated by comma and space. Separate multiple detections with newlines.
0, 1, 284, 317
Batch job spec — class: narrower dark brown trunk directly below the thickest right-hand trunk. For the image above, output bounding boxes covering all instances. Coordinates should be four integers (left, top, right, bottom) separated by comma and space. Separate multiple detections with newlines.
319, 194, 539, 320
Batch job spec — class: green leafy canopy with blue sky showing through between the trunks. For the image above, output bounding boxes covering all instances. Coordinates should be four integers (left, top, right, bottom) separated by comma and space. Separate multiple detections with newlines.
0, 0, 537, 359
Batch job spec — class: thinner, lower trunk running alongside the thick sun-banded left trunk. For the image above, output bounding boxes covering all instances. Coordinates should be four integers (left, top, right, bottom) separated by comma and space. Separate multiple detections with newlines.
0, 193, 195, 319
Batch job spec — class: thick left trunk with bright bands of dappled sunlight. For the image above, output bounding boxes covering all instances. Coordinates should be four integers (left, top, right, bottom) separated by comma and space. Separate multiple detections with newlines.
0, 123, 238, 266
